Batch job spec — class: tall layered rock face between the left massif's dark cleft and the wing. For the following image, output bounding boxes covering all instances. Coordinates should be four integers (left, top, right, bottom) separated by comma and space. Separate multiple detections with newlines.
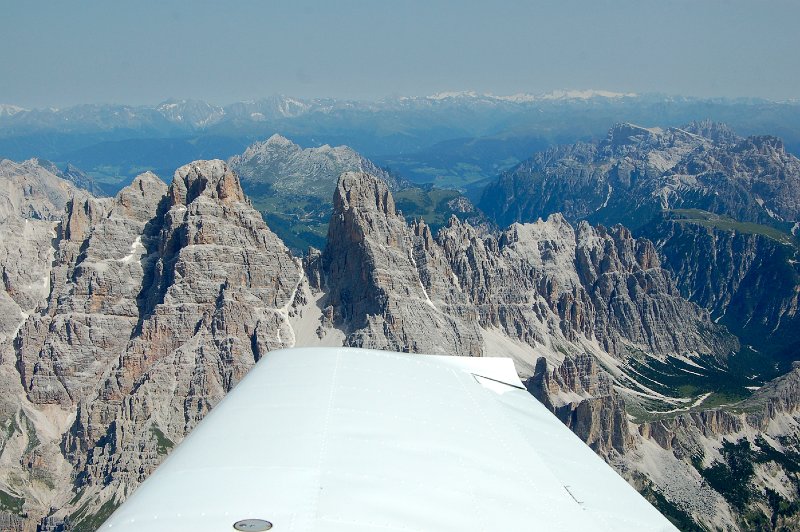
66, 161, 301, 512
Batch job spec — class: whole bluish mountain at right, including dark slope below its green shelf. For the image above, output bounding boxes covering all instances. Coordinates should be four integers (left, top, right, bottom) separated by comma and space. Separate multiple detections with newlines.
480, 122, 800, 370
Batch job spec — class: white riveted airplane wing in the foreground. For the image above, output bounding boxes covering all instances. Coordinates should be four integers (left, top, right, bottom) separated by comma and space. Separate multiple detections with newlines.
101, 348, 676, 532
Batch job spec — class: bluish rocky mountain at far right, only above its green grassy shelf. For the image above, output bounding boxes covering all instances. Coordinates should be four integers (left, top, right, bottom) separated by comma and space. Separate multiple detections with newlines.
480, 123, 800, 230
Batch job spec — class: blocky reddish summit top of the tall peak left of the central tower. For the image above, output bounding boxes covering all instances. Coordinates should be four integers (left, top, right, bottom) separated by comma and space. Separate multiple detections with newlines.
170, 159, 245, 205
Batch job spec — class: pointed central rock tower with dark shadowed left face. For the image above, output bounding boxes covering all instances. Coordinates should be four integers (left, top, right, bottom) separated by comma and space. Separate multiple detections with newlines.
323, 173, 483, 356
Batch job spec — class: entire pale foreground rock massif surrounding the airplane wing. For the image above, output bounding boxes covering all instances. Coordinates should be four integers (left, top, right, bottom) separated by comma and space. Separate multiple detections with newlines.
0, 156, 800, 530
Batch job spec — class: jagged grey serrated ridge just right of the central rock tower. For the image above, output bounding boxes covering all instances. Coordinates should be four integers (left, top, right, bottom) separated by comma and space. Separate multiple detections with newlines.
439, 215, 737, 359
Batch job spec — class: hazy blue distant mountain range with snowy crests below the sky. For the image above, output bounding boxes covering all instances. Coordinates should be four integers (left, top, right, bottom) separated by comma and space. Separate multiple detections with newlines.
0, 90, 800, 197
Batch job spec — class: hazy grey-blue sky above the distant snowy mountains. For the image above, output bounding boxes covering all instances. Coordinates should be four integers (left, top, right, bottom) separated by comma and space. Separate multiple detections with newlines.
0, 0, 800, 107
